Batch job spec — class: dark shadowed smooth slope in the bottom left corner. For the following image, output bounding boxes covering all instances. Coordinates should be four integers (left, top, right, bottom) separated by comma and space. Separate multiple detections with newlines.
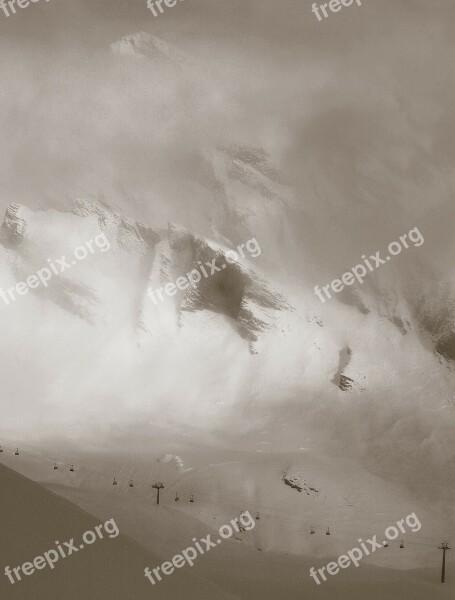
0, 465, 240, 600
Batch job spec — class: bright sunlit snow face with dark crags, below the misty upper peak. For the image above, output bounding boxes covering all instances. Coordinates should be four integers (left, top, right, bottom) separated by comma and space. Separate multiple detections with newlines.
0, 188, 454, 510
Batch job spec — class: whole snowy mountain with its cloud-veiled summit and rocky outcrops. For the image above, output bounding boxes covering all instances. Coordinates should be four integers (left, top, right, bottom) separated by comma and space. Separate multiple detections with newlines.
0, 33, 455, 528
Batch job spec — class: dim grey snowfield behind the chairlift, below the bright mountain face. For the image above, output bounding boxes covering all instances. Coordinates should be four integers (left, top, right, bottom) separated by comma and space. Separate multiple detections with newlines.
2, 451, 455, 569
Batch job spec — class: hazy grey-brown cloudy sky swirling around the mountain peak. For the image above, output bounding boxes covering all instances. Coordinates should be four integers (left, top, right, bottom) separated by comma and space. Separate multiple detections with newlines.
0, 0, 455, 270
